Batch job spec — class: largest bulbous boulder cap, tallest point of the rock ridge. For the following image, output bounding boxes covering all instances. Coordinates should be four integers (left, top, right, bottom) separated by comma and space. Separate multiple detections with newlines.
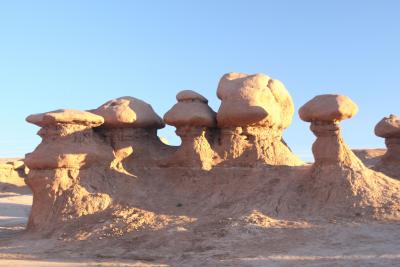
217, 72, 294, 129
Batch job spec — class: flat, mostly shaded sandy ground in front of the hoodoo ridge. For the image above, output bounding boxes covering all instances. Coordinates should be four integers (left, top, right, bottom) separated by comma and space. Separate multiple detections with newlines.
0, 192, 400, 267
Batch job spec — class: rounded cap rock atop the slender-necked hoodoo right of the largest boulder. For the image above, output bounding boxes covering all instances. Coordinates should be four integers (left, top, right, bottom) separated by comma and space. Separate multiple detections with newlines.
299, 94, 358, 122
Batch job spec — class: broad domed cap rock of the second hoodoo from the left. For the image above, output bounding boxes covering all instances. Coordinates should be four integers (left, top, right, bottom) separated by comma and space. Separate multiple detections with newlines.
91, 96, 165, 129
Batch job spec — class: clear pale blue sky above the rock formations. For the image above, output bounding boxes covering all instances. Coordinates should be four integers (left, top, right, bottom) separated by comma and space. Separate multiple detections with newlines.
0, 0, 400, 159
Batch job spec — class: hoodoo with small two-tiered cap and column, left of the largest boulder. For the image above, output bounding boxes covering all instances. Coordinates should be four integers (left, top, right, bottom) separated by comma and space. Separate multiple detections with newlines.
164, 90, 216, 169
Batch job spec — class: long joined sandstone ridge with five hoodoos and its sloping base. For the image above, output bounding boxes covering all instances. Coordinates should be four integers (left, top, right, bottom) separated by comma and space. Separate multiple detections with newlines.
20, 73, 400, 239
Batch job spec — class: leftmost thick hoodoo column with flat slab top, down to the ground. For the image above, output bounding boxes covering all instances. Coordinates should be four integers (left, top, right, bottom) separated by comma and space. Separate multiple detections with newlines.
25, 110, 112, 229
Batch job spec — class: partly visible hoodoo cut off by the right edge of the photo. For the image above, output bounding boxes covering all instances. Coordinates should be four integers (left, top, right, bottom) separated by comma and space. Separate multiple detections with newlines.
374, 114, 400, 179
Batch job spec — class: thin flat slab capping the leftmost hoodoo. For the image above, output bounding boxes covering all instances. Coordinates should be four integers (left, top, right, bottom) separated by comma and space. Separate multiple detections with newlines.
26, 109, 104, 127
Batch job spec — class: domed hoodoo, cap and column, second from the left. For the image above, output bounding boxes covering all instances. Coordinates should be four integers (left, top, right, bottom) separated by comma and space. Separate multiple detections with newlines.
91, 96, 168, 173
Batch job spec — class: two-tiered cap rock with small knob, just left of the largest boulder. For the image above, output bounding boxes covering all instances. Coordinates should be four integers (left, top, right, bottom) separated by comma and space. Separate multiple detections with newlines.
164, 90, 216, 128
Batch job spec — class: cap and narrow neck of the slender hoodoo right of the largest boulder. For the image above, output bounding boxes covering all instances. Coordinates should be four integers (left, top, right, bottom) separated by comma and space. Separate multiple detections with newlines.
299, 94, 363, 168
